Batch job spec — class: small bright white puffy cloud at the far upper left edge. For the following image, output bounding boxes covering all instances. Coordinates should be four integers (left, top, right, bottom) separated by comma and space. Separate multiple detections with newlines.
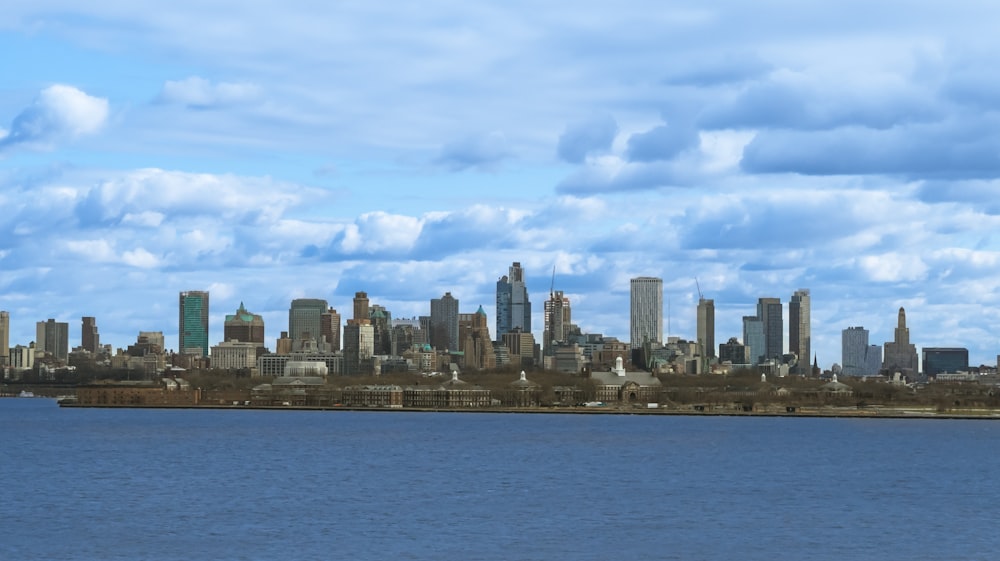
0, 84, 108, 150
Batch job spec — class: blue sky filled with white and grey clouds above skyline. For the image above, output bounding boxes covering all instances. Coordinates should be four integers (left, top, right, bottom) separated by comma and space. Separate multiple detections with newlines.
0, 0, 1000, 367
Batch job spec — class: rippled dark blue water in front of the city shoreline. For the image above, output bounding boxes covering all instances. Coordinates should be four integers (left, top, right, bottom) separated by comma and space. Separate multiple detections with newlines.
0, 398, 1000, 560
